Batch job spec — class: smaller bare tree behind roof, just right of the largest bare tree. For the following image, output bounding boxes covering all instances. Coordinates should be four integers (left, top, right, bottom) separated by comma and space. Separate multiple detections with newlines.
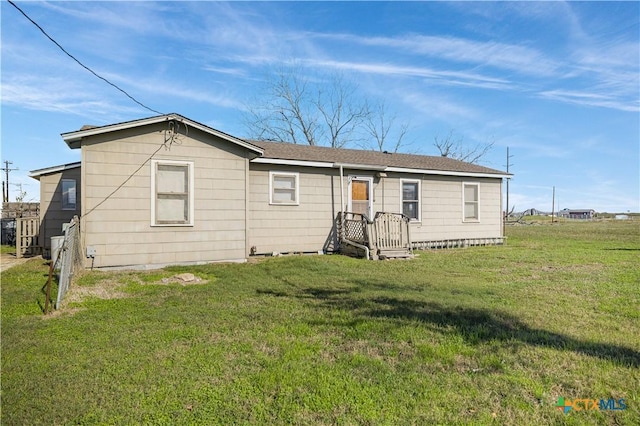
363, 102, 409, 152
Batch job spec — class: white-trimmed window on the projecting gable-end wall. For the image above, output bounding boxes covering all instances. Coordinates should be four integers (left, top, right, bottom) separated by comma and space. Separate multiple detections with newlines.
151, 160, 194, 226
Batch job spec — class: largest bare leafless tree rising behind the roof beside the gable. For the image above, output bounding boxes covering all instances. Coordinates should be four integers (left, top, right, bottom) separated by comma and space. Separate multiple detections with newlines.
245, 66, 369, 148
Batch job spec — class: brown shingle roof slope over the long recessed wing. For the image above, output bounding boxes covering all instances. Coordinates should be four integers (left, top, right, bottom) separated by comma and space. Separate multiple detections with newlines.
247, 140, 508, 175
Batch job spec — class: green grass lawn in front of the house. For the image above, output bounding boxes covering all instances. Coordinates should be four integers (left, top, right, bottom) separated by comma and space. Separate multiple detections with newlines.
1, 221, 640, 425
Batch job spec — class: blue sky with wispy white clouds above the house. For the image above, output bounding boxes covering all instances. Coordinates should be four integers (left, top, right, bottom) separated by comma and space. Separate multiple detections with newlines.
1, 1, 640, 212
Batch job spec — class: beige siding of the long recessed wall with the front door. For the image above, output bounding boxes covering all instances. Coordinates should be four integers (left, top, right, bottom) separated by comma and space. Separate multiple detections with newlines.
249, 164, 502, 253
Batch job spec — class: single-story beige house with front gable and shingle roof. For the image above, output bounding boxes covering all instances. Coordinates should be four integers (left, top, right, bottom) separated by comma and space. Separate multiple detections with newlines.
31, 114, 510, 267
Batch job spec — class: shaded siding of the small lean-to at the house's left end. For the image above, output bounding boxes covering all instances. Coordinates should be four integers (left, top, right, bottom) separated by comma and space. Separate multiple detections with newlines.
39, 167, 81, 250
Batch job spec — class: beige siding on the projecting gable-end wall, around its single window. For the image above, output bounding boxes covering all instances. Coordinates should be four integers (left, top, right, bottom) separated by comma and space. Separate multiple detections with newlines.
82, 124, 248, 267
